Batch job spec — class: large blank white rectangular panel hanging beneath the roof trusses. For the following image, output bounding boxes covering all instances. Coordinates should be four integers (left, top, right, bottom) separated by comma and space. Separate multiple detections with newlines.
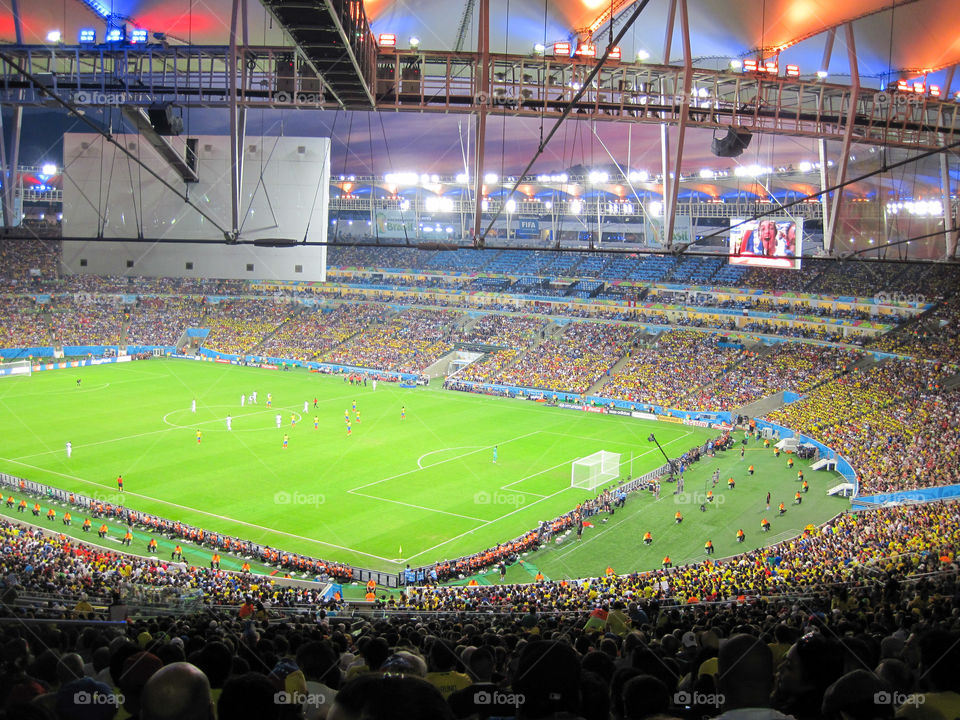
63, 133, 330, 281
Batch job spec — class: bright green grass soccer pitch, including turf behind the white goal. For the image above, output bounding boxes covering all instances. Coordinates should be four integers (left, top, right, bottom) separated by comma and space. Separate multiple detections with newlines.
0, 359, 849, 580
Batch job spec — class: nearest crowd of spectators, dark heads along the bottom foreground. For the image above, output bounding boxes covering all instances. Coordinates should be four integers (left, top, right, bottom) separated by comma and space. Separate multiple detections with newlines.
0, 503, 960, 720
